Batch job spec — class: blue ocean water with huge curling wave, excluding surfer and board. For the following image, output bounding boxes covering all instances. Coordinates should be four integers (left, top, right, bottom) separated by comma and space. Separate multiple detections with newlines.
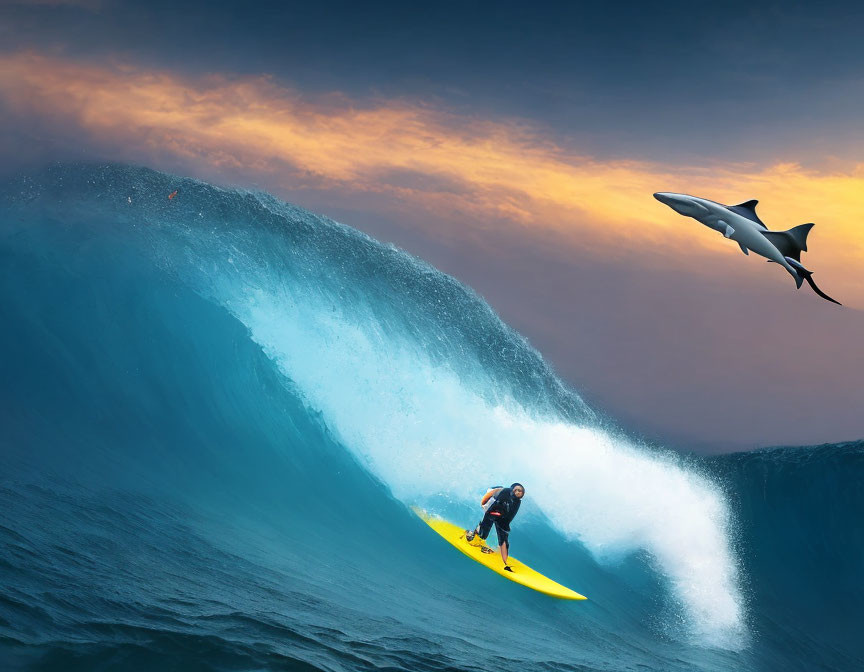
0, 165, 864, 671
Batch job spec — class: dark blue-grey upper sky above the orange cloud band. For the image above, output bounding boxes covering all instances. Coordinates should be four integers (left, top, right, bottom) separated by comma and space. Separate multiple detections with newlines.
0, 0, 864, 162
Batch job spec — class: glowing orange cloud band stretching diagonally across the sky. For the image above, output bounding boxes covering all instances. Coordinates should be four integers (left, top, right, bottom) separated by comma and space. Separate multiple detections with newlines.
0, 53, 864, 303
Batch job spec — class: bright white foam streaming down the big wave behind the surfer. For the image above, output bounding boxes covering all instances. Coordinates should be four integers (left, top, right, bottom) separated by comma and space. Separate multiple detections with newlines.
204, 272, 743, 647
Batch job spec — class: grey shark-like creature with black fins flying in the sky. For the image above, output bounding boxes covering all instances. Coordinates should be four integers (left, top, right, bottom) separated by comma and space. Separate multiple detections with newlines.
654, 191, 842, 306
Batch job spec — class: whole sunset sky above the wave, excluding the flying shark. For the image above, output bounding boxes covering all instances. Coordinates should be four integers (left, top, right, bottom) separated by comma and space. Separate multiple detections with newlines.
0, 0, 864, 452
